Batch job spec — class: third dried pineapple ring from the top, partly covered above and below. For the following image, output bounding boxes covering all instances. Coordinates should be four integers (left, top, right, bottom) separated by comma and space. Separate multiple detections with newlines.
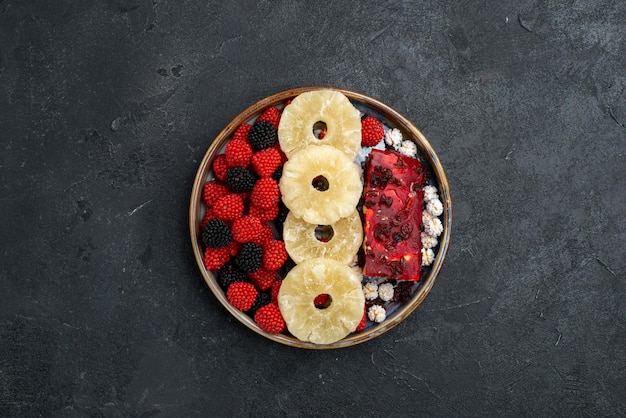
283, 208, 363, 264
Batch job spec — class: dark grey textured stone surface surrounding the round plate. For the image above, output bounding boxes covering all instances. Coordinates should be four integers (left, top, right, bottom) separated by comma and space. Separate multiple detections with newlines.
0, 0, 626, 417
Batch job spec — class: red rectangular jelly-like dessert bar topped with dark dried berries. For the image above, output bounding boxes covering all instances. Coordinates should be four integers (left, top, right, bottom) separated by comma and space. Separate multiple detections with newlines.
363, 149, 424, 281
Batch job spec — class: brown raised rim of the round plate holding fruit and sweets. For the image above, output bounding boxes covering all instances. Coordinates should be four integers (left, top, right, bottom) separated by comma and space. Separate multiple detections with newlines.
189, 86, 452, 349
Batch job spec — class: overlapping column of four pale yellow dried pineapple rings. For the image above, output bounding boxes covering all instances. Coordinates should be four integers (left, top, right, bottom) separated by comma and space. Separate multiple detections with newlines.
278, 90, 365, 344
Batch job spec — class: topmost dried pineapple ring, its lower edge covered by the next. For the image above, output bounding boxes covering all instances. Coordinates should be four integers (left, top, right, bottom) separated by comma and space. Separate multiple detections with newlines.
278, 90, 361, 160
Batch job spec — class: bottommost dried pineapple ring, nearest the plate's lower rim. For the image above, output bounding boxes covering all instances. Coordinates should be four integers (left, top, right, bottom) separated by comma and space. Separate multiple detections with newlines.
278, 258, 365, 344
